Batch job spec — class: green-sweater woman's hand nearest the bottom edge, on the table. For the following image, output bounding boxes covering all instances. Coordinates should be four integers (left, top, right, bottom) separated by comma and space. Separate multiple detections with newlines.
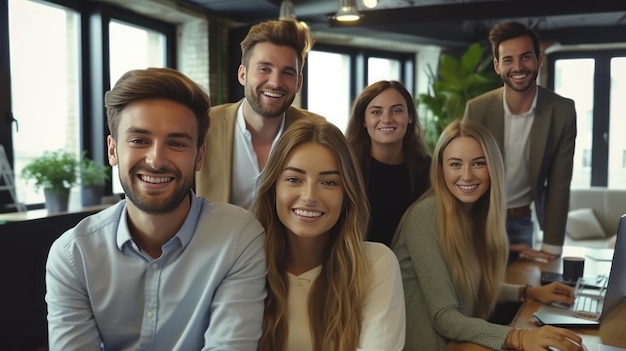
522, 326, 584, 351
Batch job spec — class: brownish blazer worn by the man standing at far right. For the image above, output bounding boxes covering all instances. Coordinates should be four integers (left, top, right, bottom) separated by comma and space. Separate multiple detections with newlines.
464, 87, 576, 246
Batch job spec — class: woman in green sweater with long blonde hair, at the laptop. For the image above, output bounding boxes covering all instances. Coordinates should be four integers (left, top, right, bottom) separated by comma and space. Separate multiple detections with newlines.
393, 119, 582, 351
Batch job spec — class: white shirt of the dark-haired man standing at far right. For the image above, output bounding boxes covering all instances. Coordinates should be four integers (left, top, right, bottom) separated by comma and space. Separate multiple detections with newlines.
502, 91, 537, 208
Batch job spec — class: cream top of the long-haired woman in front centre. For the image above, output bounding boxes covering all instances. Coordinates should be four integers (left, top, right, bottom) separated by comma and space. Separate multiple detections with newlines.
286, 242, 406, 351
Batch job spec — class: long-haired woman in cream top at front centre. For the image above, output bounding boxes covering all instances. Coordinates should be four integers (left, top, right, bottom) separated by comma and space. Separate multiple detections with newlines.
253, 120, 405, 351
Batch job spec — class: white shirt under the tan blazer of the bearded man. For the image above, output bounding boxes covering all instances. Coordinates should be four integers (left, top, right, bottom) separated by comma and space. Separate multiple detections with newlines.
230, 100, 285, 210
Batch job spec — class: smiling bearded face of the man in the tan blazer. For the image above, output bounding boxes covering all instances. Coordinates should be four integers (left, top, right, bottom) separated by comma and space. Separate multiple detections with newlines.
237, 42, 302, 118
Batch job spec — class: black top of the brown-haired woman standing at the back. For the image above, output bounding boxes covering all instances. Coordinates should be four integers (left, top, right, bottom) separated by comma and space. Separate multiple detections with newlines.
366, 157, 430, 246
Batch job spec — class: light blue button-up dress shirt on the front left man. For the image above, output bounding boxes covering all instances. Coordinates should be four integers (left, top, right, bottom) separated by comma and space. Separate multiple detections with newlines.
46, 193, 266, 351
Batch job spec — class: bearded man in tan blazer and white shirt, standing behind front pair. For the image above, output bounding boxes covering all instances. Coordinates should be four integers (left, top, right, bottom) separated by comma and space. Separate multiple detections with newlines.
196, 20, 322, 209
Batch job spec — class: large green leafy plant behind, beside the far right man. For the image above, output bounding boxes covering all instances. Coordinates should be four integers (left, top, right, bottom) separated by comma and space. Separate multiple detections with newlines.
418, 43, 502, 150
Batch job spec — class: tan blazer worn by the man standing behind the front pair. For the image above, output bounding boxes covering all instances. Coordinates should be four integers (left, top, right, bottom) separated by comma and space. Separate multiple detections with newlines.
196, 99, 322, 202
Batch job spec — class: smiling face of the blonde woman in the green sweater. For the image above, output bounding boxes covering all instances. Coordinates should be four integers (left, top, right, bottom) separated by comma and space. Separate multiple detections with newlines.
441, 137, 490, 209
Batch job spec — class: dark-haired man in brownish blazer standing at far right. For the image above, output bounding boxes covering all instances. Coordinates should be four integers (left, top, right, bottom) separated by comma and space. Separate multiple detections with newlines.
464, 22, 576, 260
